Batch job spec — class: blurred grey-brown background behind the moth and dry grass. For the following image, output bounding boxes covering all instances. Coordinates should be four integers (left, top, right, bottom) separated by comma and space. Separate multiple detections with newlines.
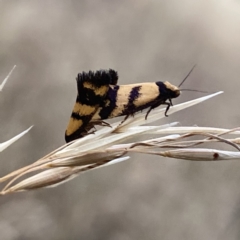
0, 0, 240, 240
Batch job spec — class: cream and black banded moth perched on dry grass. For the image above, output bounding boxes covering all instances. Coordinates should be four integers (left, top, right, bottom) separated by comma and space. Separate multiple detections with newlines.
65, 69, 182, 142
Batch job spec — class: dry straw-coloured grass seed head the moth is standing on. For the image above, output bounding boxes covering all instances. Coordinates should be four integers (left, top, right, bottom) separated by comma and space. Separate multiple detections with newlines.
0, 92, 240, 195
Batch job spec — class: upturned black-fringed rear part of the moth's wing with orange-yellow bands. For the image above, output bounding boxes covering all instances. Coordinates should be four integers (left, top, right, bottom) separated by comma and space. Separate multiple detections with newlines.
65, 69, 118, 142
